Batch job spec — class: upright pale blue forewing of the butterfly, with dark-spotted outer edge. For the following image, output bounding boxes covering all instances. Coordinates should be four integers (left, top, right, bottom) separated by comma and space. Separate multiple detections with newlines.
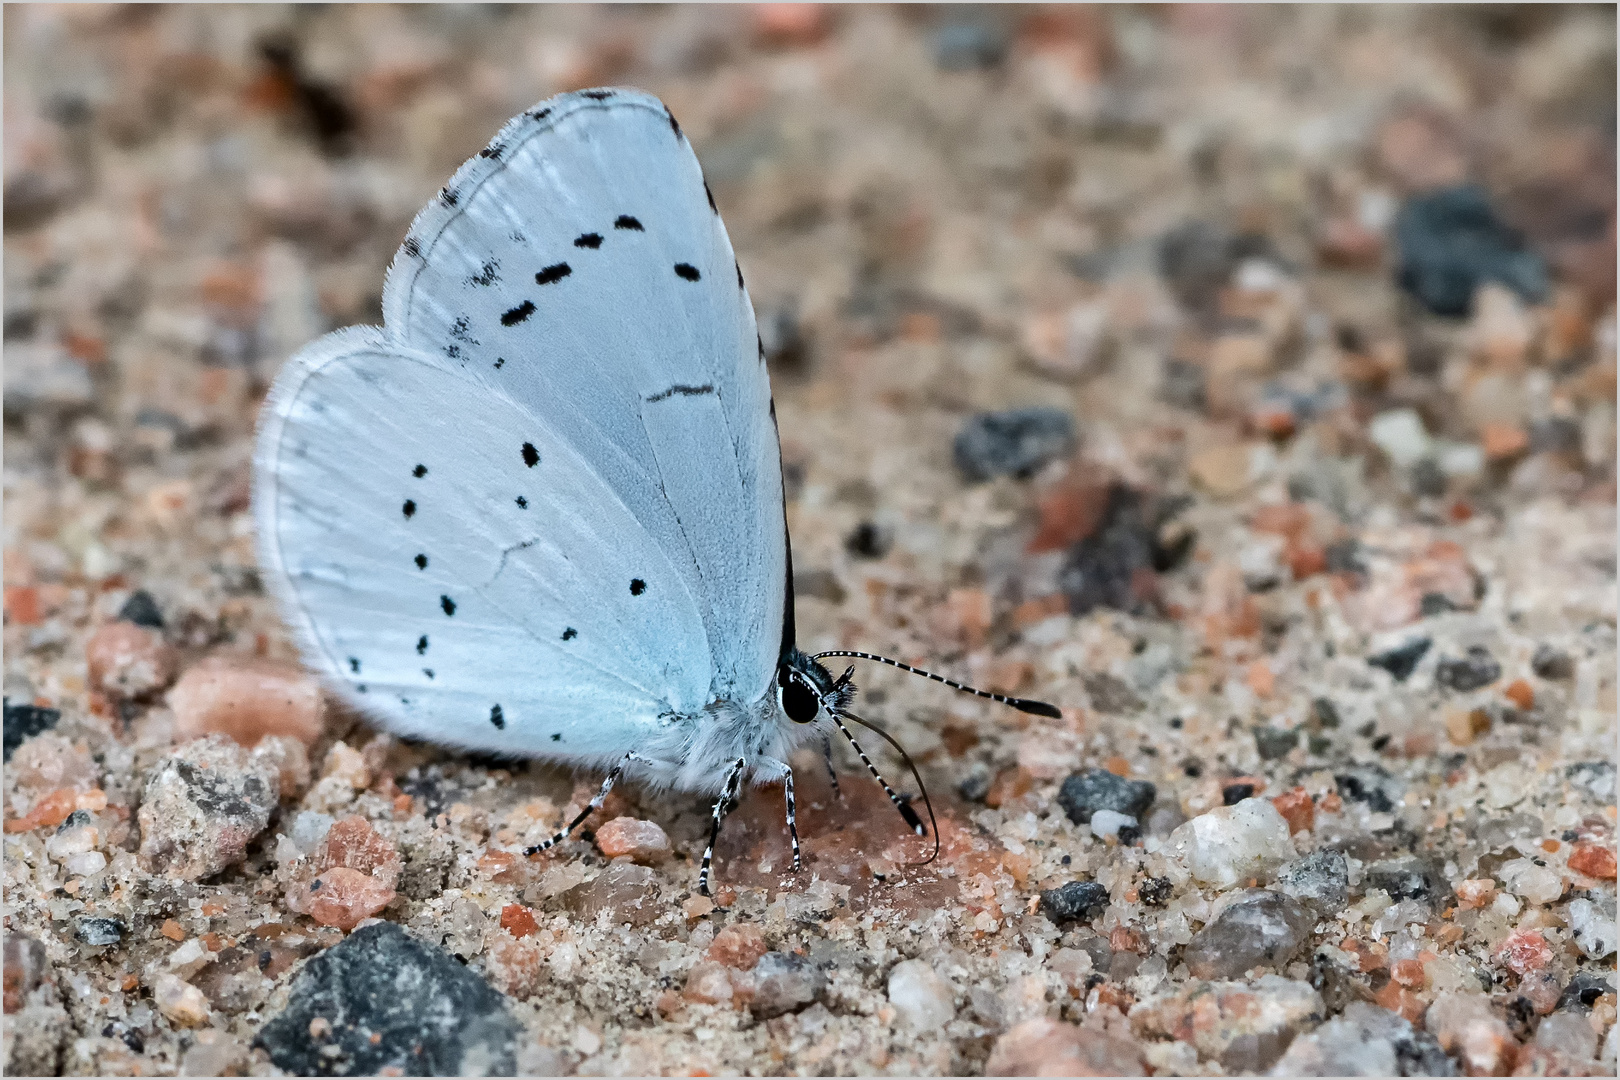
384, 91, 786, 699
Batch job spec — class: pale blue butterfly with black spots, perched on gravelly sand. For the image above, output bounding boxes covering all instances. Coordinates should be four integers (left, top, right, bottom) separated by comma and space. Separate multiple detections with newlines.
254, 89, 1058, 892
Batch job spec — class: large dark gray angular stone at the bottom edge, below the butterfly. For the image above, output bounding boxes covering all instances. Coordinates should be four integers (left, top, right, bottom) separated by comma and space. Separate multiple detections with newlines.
254, 923, 522, 1077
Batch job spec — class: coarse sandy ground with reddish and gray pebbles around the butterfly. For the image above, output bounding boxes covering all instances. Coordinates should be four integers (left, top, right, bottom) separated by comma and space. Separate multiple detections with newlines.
5, 5, 1615, 1075
